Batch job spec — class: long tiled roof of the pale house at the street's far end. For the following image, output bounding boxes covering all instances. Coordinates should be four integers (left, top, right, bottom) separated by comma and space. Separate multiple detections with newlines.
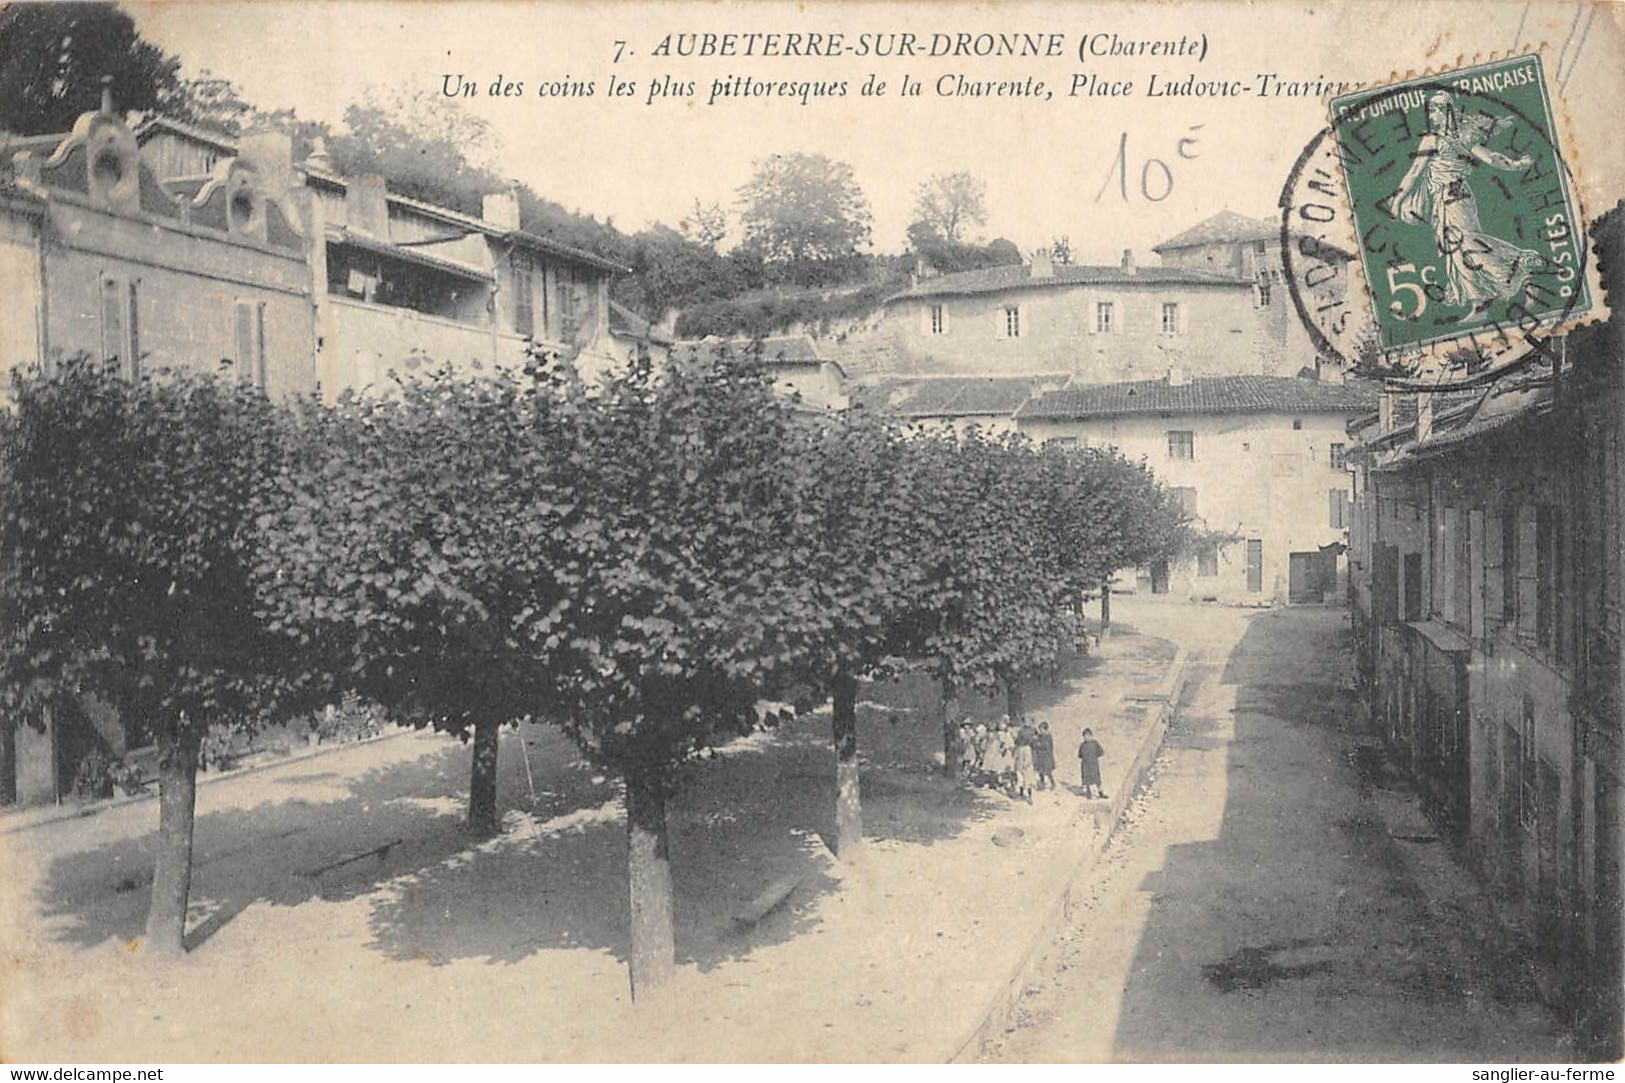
1016, 376, 1376, 418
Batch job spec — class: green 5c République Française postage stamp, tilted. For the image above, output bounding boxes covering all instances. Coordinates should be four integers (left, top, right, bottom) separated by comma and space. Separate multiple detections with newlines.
1331, 54, 1596, 354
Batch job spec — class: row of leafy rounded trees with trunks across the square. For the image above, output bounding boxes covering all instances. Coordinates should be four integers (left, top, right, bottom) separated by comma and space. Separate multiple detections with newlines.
0, 347, 1183, 994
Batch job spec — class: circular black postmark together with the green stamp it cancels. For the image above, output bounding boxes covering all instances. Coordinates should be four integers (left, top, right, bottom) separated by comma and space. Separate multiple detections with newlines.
1281, 57, 1589, 381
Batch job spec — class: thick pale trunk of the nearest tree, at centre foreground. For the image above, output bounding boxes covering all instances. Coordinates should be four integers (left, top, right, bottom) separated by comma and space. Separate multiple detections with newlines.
626, 774, 678, 1003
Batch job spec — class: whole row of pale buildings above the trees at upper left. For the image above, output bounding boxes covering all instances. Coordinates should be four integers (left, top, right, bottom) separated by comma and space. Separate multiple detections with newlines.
0, 102, 619, 398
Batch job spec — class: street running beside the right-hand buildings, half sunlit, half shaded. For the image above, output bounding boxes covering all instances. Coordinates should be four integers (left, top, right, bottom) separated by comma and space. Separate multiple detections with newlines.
986, 605, 1571, 1062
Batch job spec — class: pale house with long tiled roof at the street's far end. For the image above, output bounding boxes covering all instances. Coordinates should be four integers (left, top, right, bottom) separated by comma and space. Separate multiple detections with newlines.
1014, 372, 1376, 603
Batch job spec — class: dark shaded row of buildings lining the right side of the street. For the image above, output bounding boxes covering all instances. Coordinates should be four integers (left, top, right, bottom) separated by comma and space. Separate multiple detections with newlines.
1350, 210, 1625, 1059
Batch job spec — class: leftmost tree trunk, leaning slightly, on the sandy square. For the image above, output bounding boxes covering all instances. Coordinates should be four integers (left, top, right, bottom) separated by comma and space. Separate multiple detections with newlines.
146, 722, 203, 959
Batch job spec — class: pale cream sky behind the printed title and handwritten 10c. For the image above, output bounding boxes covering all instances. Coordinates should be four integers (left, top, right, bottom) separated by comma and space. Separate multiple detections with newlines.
125, 0, 1625, 262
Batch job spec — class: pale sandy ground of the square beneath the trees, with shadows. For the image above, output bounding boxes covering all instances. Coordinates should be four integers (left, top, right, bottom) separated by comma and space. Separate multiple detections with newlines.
0, 611, 1175, 1062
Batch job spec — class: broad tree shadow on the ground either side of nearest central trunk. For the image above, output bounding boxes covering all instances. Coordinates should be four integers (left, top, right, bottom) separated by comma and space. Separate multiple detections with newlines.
371, 708, 996, 971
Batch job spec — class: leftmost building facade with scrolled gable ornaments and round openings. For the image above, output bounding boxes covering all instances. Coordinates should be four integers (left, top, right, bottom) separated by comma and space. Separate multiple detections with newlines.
0, 93, 317, 392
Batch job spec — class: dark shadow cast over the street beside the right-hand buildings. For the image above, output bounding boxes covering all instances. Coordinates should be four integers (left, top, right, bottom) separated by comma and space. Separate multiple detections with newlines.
1115, 610, 1537, 1062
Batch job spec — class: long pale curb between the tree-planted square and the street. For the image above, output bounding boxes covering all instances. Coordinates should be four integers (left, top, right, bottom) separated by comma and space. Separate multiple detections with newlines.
946, 647, 1190, 1063
